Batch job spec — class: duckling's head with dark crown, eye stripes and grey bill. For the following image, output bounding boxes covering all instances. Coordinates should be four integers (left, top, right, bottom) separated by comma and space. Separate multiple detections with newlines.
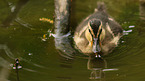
88, 19, 102, 53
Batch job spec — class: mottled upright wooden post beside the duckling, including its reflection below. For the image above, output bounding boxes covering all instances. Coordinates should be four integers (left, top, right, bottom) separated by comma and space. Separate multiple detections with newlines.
54, 0, 75, 59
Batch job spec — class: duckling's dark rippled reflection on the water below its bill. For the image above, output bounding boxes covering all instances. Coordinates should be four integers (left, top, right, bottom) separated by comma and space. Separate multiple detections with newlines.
87, 54, 107, 79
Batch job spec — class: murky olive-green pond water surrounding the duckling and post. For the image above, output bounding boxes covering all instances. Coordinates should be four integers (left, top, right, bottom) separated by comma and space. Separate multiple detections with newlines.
0, 0, 145, 81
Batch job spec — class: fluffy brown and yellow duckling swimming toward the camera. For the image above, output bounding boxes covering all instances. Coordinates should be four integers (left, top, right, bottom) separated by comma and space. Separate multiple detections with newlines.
74, 2, 123, 55
